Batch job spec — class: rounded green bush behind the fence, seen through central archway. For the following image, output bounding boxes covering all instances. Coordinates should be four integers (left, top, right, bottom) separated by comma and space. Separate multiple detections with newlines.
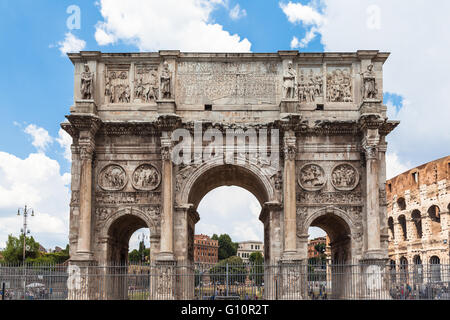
209, 256, 247, 284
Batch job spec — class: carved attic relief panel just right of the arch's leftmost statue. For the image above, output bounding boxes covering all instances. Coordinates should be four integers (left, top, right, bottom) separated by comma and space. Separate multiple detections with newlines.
105, 65, 131, 103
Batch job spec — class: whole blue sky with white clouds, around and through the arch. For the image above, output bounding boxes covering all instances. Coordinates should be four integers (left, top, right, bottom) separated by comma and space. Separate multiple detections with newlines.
0, 0, 450, 248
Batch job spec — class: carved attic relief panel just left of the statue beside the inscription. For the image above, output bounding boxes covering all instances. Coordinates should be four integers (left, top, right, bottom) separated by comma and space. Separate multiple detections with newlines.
134, 65, 159, 103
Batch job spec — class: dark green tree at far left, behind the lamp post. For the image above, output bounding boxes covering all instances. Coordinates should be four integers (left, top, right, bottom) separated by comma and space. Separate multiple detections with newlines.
3, 234, 40, 263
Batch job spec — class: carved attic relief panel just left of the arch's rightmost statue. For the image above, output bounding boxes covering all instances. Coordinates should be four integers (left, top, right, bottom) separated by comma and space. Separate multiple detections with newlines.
327, 67, 353, 102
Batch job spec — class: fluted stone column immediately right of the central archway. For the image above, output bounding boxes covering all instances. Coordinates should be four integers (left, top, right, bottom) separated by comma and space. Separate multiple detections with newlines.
283, 130, 297, 258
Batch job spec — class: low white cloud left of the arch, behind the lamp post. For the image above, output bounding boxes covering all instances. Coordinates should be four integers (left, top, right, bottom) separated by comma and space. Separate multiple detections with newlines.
0, 152, 70, 248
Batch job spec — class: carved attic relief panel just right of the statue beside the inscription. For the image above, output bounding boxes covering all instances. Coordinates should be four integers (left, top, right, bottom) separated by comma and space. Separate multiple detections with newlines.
298, 68, 324, 103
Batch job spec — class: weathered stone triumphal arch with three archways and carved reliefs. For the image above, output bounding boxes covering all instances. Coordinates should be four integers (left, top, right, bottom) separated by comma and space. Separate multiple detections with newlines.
62, 50, 398, 299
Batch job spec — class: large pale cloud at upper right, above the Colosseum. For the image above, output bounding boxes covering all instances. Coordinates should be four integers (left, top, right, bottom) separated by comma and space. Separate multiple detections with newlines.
280, 0, 450, 171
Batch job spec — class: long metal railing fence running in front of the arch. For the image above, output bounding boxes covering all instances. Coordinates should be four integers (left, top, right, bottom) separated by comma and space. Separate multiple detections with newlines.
0, 263, 450, 300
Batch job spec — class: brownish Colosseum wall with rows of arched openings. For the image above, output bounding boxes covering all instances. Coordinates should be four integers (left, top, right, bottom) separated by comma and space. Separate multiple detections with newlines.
386, 156, 450, 278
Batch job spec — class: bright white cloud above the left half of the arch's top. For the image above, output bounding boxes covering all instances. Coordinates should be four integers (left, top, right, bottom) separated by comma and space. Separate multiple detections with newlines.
95, 0, 251, 52
